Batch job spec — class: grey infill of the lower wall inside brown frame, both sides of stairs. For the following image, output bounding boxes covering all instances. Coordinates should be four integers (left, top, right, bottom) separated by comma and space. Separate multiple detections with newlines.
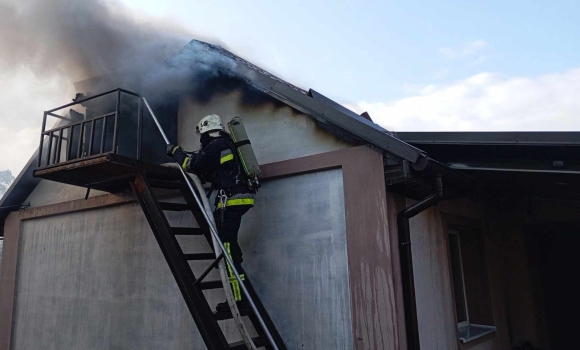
12, 170, 353, 350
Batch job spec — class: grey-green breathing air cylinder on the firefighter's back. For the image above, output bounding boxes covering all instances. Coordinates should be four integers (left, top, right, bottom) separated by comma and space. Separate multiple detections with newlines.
228, 117, 261, 189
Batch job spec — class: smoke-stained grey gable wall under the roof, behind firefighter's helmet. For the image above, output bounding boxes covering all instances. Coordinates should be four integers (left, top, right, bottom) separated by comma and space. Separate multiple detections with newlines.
178, 91, 351, 164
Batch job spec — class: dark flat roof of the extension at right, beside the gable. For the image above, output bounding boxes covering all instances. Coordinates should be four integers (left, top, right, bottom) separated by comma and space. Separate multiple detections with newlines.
396, 132, 580, 200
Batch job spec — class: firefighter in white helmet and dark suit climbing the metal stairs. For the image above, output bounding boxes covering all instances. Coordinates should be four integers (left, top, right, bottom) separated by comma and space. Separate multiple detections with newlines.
166, 114, 255, 311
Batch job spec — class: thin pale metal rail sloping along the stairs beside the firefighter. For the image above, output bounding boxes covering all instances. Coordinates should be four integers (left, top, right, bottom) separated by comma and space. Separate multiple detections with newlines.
141, 97, 279, 350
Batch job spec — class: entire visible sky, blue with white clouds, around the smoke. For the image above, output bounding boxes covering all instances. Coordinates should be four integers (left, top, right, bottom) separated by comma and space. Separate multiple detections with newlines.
0, 0, 580, 174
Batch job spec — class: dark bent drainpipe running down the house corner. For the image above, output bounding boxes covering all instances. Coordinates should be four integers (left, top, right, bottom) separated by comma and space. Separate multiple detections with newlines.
397, 174, 444, 350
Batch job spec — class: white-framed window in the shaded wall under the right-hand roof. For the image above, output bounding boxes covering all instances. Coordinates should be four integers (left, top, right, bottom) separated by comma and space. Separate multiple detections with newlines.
449, 229, 496, 343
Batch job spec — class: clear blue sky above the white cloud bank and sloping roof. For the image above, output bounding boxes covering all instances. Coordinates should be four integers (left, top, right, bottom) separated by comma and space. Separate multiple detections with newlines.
123, 0, 580, 103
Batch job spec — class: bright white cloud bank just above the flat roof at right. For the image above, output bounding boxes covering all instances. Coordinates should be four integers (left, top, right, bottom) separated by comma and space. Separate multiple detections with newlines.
349, 68, 580, 131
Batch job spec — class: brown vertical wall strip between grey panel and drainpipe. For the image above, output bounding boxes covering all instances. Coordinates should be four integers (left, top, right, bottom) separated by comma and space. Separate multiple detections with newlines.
343, 147, 400, 349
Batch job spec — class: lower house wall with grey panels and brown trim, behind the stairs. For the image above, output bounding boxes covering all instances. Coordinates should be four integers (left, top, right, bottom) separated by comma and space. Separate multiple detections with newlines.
0, 146, 404, 350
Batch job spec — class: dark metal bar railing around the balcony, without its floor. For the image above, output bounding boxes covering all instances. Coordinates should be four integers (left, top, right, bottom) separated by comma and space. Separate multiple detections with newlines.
38, 88, 143, 168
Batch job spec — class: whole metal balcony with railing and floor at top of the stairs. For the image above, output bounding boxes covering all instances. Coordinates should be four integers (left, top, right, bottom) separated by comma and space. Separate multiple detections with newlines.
33, 88, 179, 193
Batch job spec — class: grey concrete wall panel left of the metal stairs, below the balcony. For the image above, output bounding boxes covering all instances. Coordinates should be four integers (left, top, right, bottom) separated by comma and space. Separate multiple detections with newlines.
12, 205, 202, 349
